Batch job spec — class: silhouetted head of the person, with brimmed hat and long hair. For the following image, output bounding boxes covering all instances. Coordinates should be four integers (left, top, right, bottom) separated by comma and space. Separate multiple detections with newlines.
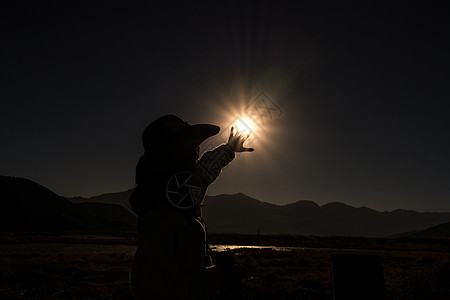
129, 115, 220, 215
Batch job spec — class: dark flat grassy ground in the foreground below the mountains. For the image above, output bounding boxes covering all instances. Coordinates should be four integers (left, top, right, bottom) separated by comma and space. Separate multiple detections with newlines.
0, 233, 450, 299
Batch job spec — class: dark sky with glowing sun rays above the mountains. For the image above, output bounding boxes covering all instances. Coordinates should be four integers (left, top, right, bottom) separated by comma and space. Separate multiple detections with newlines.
0, 1, 450, 211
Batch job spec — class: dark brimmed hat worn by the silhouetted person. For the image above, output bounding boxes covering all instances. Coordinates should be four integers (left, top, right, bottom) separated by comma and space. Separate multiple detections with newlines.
142, 115, 220, 159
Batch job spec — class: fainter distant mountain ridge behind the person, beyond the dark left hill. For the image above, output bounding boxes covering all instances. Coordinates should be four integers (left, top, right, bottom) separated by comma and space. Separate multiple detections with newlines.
71, 190, 450, 237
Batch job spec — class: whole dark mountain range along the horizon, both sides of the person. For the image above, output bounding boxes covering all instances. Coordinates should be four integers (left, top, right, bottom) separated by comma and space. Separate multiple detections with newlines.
0, 176, 450, 237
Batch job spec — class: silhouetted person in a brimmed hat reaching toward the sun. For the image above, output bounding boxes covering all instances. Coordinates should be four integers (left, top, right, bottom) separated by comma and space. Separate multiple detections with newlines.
130, 115, 253, 299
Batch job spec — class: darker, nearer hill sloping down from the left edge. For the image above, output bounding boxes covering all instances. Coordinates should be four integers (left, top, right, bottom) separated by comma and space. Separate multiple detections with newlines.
0, 176, 136, 231
